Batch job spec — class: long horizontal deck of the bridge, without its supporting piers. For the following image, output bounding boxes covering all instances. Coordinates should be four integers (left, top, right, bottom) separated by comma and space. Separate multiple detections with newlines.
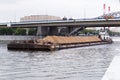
3, 19, 120, 28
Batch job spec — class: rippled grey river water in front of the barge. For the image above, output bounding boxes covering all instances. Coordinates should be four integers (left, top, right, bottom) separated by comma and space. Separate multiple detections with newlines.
0, 37, 120, 80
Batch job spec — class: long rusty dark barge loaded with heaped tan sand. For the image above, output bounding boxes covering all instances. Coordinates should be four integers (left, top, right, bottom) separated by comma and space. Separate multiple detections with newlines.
7, 36, 113, 51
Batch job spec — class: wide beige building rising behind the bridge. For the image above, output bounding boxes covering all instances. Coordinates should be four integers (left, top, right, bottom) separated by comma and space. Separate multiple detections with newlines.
20, 15, 61, 22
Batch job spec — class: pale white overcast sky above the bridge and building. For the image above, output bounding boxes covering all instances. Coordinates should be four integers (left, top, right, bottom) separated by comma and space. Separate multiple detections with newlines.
0, 0, 120, 22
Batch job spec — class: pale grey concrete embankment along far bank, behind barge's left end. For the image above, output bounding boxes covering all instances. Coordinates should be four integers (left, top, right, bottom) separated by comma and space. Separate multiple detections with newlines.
0, 35, 36, 43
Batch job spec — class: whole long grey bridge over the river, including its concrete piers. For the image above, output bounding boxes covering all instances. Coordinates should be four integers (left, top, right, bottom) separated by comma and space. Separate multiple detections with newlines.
0, 12, 120, 36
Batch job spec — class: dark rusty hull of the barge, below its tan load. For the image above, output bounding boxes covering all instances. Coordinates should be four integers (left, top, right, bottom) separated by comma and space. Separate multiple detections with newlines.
7, 41, 112, 51
